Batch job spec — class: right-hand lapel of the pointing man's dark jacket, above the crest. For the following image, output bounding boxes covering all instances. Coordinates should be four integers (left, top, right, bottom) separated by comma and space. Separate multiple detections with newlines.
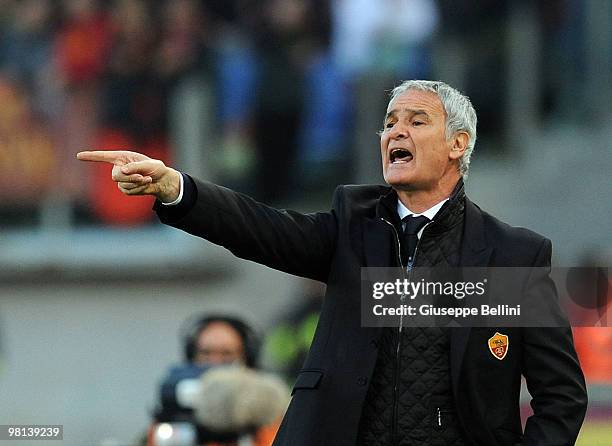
450, 198, 493, 397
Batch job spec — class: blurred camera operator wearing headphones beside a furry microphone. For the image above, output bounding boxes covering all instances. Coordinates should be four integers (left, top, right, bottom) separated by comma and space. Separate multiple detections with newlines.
146, 315, 289, 446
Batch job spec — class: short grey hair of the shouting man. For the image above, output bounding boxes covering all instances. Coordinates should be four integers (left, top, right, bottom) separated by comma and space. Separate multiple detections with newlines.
389, 80, 477, 178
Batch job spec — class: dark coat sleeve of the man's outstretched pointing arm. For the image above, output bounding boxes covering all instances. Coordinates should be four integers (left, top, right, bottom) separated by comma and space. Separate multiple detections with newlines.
154, 175, 341, 282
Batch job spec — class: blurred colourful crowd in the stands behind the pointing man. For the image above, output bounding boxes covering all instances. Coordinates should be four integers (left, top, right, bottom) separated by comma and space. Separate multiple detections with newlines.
0, 0, 584, 226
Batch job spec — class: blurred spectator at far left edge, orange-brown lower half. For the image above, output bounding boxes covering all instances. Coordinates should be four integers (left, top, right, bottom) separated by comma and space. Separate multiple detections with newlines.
0, 0, 56, 224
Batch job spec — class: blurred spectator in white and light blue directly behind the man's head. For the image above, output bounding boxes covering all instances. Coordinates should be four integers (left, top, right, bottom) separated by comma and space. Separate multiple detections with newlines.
331, 0, 440, 183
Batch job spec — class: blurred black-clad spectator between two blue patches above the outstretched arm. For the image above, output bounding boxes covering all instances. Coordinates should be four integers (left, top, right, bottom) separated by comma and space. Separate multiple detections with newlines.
254, 0, 329, 203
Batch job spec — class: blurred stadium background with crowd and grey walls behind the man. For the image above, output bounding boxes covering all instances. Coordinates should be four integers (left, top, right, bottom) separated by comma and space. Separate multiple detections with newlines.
0, 0, 612, 446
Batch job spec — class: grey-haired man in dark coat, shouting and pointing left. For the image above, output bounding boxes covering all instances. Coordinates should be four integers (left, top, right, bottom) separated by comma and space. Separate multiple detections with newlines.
78, 81, 587, 446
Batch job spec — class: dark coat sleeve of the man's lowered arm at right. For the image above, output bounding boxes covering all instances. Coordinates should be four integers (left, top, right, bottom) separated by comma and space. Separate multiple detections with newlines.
521, 239, 587, 446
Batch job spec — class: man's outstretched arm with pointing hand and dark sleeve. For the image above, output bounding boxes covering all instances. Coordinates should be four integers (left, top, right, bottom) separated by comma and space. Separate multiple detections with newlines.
77, 151, 341, 282
